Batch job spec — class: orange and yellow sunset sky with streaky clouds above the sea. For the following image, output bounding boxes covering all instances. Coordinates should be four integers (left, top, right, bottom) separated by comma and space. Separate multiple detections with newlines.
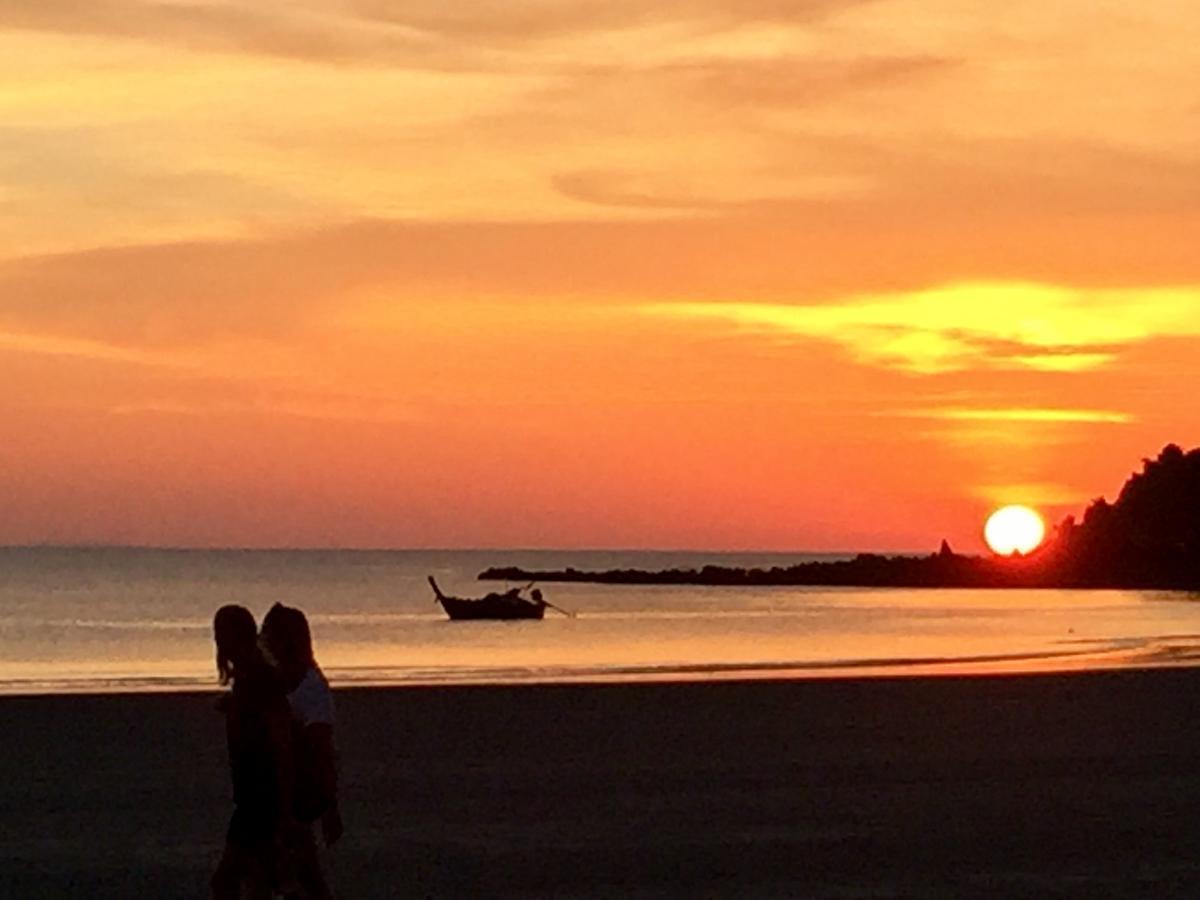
0, 0, 1200, 551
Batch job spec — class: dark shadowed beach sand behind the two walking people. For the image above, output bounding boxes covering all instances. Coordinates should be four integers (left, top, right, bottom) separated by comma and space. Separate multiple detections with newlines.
0, 670, 1200, 900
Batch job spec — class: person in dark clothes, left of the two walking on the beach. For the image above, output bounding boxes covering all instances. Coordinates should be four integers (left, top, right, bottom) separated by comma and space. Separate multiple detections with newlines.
211, 606, 292, 900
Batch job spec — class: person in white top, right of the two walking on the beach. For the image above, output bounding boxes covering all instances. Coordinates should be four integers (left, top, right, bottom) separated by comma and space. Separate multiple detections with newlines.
263, 604, 342, 900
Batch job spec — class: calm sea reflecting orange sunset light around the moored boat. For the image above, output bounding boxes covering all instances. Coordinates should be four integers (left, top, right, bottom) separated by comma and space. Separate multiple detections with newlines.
0, 548, 1200, 694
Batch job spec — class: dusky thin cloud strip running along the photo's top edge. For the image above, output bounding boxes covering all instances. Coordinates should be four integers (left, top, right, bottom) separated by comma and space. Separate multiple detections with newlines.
0, 0, 872, 68
